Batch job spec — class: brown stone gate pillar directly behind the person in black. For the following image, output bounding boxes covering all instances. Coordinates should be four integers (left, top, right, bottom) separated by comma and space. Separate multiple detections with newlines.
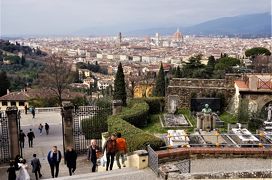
62, 103, 75, 149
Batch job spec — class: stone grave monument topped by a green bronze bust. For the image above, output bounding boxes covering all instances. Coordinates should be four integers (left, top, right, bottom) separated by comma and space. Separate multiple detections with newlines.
196, 104, 216, 131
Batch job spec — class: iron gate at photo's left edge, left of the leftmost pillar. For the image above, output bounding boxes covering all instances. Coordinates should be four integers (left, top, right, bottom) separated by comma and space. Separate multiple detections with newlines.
0, 111, 10, 163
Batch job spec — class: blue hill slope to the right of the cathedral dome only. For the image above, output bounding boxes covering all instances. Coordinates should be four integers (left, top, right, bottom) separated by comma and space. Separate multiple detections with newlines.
183, 13, 271, 36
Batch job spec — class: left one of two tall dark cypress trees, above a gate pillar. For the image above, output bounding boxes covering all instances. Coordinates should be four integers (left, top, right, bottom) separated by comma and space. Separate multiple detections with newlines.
113, 63, 127, 106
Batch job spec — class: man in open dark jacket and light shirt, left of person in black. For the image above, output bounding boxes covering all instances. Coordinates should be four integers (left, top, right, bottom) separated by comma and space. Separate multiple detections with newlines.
47, 146, 61, 178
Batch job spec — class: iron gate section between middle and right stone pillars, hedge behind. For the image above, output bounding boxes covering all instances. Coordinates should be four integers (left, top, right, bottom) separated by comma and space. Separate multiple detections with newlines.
73, 105, 112, 154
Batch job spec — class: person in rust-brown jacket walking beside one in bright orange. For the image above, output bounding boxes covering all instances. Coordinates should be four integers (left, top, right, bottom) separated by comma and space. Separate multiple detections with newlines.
103, 134, 117, 171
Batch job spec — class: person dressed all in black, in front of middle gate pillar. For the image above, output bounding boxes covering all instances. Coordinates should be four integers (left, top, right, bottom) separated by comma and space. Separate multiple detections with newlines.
65, 146, 77, 176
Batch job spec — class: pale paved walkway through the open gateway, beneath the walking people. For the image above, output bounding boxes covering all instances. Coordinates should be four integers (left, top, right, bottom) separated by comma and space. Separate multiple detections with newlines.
0, 112, 136, 180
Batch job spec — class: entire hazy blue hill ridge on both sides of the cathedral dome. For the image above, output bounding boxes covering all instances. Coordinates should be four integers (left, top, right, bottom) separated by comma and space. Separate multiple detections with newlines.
124, 13, 271, 37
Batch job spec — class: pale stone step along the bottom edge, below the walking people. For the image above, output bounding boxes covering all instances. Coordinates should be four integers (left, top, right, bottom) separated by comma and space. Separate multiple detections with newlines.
44, 168, 160, 180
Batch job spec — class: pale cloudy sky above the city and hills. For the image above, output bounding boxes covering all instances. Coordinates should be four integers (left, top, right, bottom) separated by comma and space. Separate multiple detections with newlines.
0, 0, 271, 36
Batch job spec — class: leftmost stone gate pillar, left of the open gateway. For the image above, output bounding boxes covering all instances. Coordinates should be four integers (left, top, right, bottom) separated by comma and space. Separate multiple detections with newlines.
6, 107, 20, 159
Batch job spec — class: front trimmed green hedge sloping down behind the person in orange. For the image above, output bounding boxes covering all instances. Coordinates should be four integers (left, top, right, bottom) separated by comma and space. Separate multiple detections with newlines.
108, 115, 165, 152
